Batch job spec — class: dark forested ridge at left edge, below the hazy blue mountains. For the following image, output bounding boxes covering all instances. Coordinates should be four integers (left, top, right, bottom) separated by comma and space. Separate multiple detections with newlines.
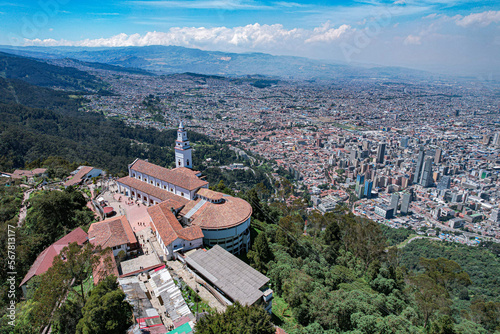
0, 52, 106, 91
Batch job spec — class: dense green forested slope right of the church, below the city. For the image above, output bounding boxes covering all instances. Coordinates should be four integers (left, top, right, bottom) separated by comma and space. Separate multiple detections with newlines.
239, 192, 500, 334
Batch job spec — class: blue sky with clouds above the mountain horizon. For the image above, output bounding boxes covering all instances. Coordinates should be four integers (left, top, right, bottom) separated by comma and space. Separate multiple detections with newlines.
0, 0, 500, 76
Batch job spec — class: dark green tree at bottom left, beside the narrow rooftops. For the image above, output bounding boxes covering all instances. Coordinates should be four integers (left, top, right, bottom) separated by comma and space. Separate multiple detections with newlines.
76, 275, 132, 334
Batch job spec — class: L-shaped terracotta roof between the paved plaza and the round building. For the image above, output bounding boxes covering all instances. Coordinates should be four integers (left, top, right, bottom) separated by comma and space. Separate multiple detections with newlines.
148, 201, 203, 245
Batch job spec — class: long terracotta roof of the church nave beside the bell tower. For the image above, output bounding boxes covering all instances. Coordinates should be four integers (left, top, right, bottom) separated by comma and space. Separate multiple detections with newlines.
130, 159, 208, 190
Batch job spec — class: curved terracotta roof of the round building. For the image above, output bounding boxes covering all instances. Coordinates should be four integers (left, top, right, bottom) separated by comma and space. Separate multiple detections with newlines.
180, 195, 252, 230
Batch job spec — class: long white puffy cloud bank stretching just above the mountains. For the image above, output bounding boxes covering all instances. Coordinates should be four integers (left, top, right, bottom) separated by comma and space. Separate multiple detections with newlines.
25, 23, 354, 51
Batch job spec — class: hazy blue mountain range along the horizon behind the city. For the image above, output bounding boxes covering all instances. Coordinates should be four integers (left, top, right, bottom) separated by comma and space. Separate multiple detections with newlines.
0, 46, 438, 80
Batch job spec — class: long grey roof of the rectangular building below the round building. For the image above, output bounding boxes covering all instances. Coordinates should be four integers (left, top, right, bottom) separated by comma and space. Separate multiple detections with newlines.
186, 245, 269, 305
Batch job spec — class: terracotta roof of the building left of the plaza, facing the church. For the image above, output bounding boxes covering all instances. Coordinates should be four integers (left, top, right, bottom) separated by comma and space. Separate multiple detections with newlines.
89, 216, 137, 248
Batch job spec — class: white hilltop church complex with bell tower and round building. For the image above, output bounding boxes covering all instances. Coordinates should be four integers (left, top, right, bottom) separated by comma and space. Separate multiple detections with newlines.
117, 122, 252, 259
